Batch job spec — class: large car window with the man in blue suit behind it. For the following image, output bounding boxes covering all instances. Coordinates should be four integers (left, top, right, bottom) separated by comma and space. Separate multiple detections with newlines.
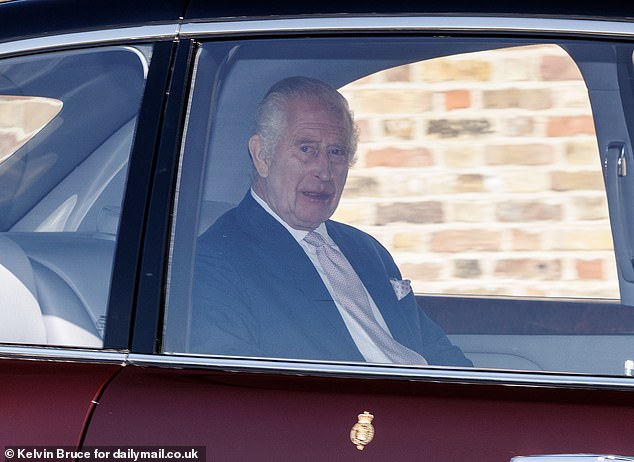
163, 37, 632, 375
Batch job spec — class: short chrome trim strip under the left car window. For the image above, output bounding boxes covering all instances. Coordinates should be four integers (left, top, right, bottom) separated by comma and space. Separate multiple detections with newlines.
0, 345, 128, 366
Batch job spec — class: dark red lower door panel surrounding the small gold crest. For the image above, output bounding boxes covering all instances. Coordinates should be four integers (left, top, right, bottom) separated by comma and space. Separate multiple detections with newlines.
85, 366, 634, 462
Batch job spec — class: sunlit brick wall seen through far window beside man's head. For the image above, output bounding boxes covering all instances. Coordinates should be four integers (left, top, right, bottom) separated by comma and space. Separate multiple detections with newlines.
335, 45, 619, 298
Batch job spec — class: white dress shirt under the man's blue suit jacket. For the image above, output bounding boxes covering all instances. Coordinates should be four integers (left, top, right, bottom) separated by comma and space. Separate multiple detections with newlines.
251, 190, 392, 363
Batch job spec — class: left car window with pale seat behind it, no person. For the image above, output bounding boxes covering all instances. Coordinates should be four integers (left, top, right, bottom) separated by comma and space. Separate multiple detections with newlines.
0, 47, 151, 348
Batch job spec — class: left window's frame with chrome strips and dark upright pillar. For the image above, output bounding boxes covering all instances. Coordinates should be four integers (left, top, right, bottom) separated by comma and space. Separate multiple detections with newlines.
0, 23, 178, 358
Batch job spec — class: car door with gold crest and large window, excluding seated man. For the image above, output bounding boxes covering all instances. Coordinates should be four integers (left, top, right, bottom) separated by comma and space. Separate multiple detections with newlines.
84, 12, 634, 461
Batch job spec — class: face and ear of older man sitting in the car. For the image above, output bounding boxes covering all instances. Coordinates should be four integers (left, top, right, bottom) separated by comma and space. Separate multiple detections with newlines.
249, 99, 351, 231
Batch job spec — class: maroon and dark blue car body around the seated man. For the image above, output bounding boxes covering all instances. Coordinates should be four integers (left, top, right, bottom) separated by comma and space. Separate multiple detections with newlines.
0, 0, 634, 462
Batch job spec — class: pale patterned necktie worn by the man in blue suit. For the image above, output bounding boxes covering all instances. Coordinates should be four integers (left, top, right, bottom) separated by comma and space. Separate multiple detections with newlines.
304, 231, 427, 364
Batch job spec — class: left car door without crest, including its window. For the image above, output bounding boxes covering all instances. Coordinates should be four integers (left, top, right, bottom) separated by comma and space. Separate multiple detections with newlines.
0, 19, 175, 448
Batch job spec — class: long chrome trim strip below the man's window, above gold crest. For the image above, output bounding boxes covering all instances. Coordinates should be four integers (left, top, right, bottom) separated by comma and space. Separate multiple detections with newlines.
128, 353, 634, 391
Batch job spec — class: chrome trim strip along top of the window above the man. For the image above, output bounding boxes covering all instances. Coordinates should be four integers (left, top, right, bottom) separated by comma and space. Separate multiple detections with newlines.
180, 16, 634, 38
